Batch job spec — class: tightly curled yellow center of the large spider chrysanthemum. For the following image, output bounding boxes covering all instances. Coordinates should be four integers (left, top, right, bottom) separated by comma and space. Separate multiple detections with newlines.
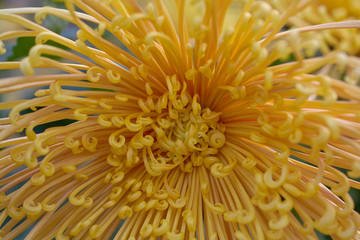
105, 76, 225, 176
